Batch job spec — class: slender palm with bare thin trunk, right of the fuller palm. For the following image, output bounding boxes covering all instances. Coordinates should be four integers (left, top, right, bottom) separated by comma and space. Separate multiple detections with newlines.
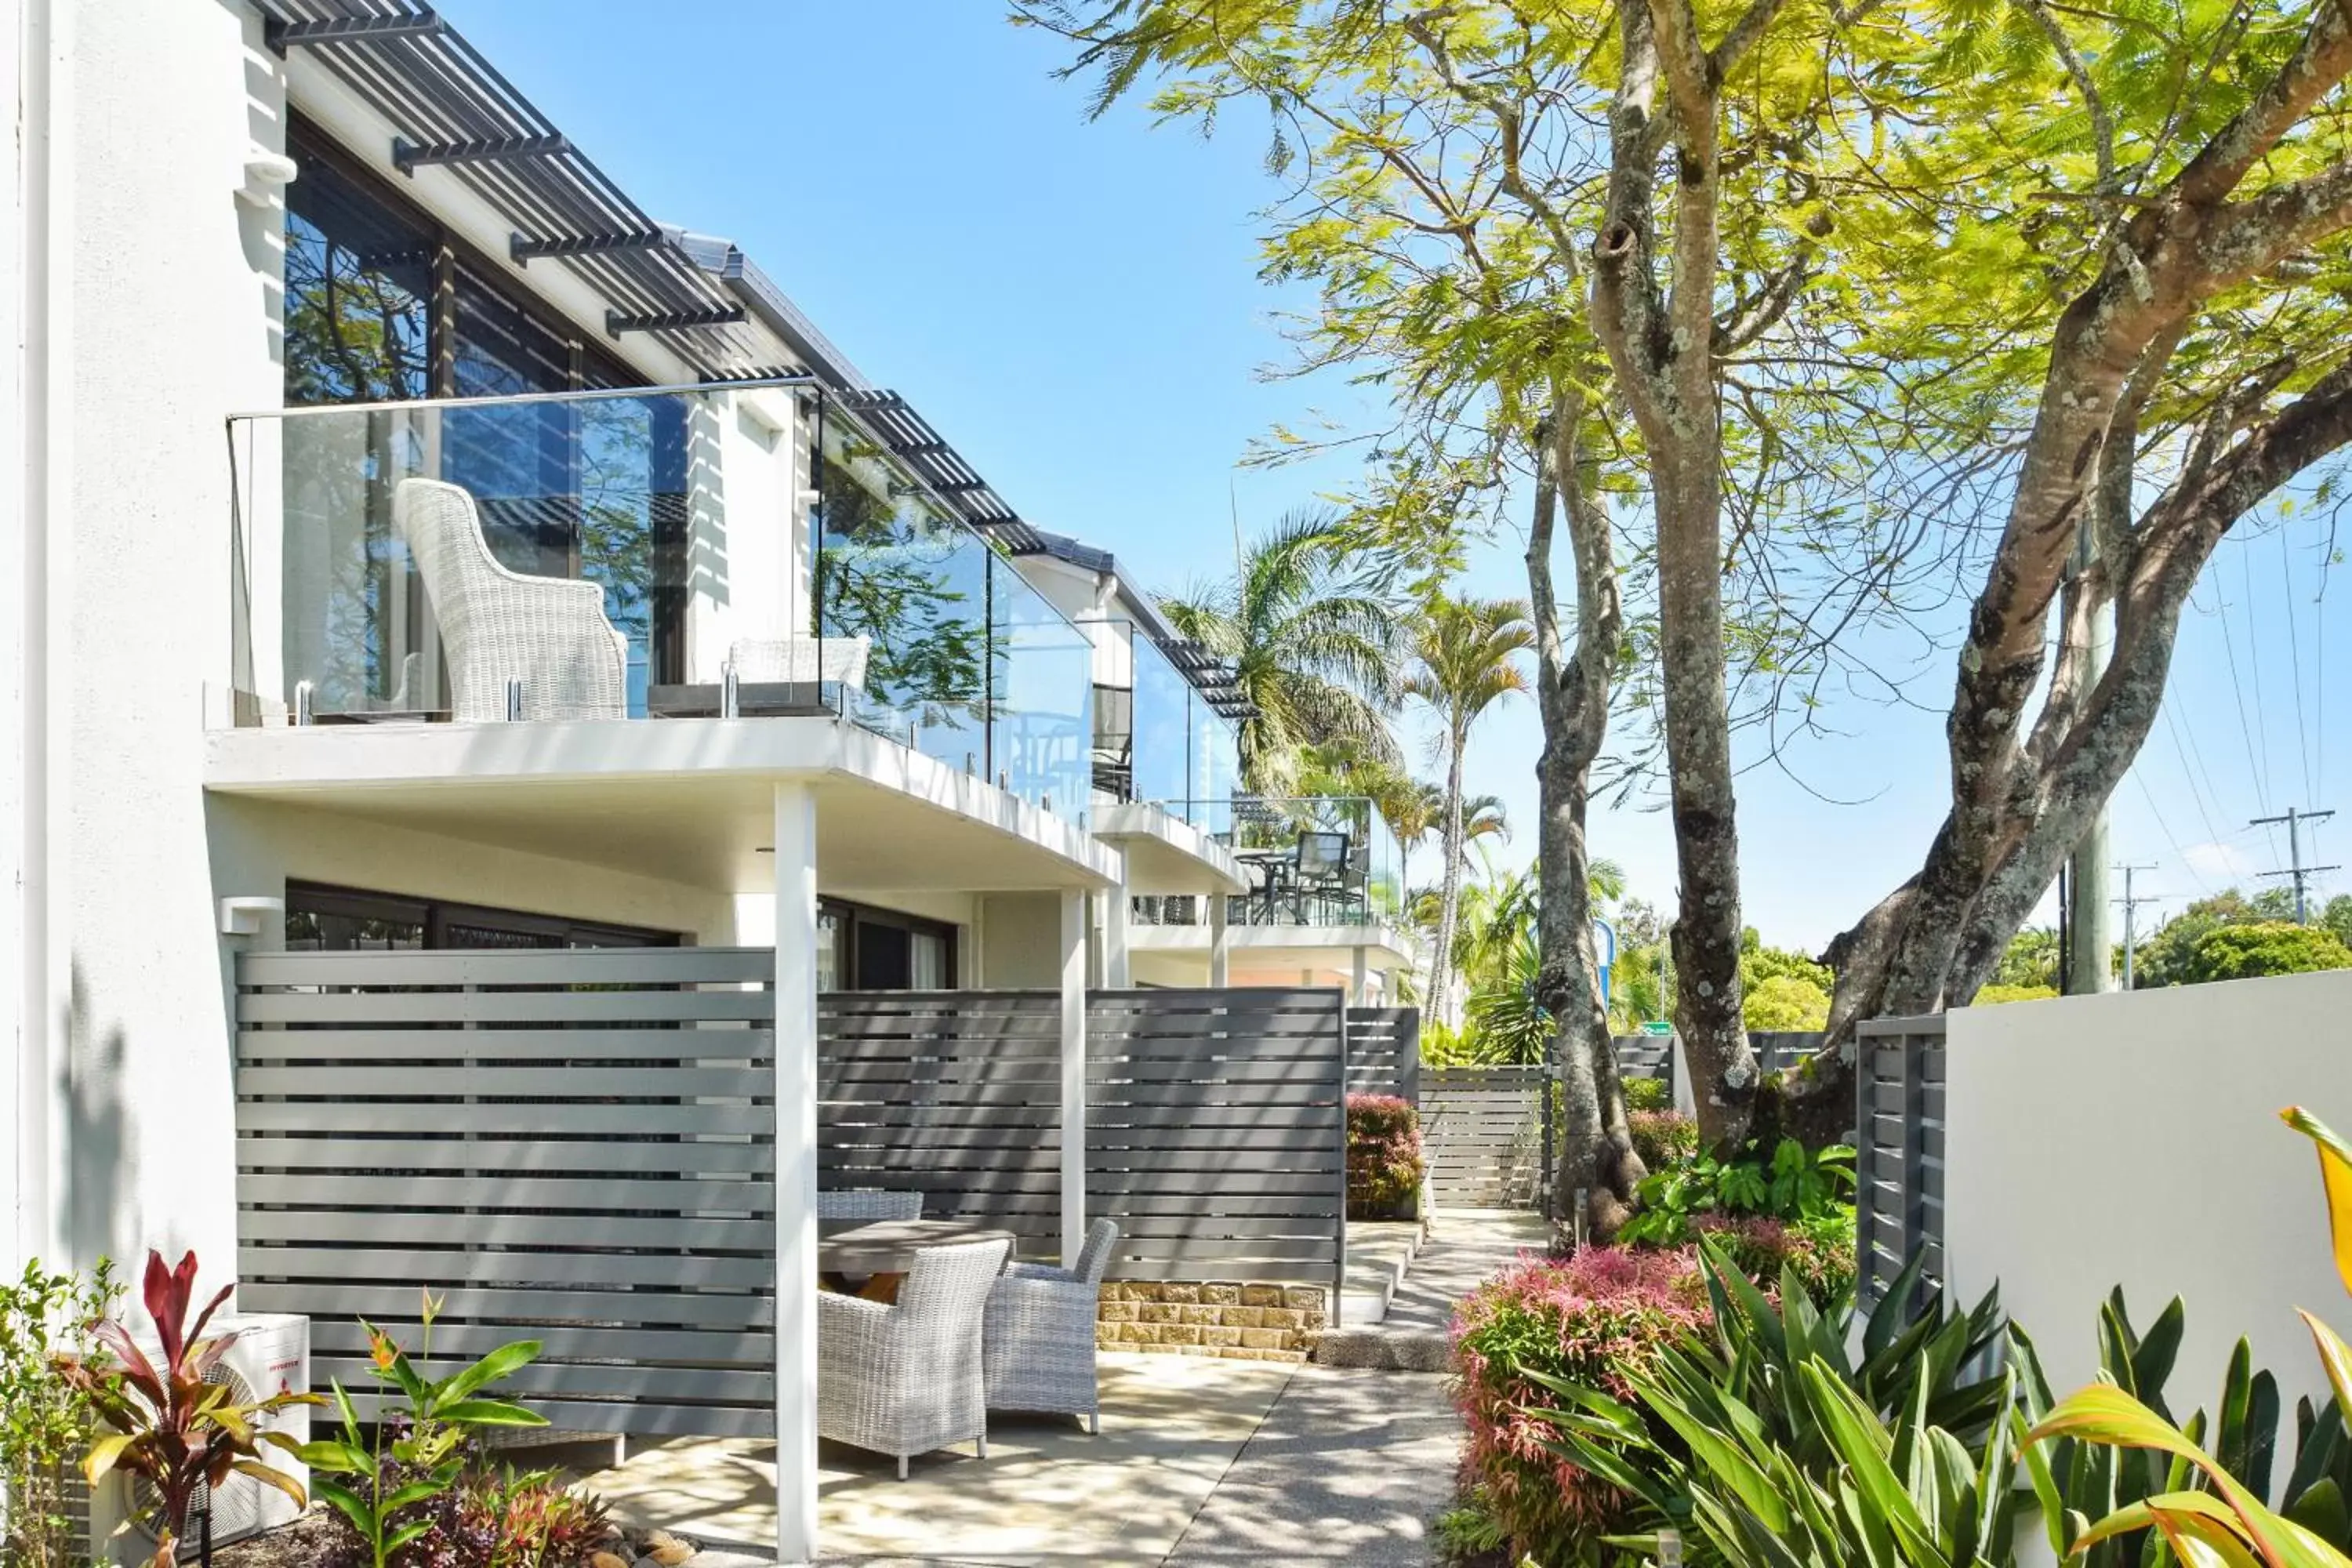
1404, 595, 1536, 1027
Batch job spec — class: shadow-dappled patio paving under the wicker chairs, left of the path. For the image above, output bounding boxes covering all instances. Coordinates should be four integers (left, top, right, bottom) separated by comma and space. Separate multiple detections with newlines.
588, 1352, 1289, 1568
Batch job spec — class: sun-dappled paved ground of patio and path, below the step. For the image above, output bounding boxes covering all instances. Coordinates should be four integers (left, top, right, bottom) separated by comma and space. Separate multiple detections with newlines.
586, 1352, 1461, 1568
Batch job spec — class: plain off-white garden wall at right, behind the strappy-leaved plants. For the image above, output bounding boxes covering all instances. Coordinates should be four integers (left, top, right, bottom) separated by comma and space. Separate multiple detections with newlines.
1945, 973, 2352, 1465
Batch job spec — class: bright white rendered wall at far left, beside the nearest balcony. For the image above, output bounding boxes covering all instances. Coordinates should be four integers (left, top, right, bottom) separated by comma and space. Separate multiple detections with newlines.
47, 0, 282, 1269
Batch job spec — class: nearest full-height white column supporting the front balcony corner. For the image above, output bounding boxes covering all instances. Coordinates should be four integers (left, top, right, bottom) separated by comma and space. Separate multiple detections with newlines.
776, 783, 816, 1563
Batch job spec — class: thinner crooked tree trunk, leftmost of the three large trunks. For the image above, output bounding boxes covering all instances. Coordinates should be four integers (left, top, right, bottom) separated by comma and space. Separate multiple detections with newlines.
1526, 388, 1644, 1239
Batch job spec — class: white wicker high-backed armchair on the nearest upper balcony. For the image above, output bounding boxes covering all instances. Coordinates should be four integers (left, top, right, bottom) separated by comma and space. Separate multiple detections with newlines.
393, 480, 628, 724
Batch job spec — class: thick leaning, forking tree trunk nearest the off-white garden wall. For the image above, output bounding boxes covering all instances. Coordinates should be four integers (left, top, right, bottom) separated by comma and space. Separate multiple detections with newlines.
1769, 5, 2352, 1135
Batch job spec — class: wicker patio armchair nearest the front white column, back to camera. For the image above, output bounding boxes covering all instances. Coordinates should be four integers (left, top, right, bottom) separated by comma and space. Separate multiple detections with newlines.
816, 1241, 1014, 1481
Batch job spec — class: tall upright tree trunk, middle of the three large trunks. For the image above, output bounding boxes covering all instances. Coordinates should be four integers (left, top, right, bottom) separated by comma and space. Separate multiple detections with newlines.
1592, 0, 1773, 1145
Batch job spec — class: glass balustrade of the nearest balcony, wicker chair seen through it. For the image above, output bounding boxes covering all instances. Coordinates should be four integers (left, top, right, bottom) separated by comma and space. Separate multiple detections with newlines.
226, 379, 1094, 822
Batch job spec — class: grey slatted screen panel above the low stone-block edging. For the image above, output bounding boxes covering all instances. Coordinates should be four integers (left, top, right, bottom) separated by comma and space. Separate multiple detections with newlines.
1087, 987, 1348, 1288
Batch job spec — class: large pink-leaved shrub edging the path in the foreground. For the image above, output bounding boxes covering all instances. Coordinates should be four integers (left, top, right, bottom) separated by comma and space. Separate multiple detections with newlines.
1454, 1246, 1710, 1563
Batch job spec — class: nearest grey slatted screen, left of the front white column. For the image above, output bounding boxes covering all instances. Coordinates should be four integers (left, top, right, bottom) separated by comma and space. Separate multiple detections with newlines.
238, 947, 776, 1436
